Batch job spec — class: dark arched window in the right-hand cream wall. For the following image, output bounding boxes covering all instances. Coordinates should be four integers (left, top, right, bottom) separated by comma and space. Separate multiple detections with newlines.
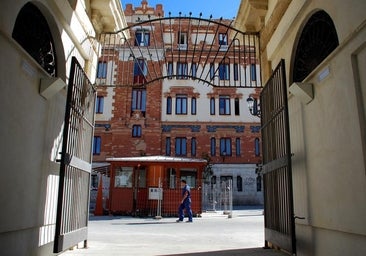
292, 11, 339, 82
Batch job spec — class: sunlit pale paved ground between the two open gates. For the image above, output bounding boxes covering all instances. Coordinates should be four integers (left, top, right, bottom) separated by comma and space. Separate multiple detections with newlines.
61, 209, 286, 256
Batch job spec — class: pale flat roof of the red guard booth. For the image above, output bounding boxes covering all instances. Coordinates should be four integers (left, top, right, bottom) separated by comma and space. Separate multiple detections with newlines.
106, 156, 207, 163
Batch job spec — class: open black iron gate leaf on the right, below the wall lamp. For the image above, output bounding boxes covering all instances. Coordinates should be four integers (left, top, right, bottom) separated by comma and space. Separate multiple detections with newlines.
260, 60, 296, 254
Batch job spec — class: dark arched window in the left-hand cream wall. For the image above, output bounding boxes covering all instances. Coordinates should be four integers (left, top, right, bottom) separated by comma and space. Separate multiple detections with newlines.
12, 3, 57, 77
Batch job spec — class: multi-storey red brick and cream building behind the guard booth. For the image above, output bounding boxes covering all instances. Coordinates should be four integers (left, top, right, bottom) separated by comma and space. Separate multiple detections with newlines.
93, 1, 263, 214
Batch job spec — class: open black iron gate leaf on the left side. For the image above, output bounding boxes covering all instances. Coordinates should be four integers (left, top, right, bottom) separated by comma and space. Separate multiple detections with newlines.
54, 57, 95, 253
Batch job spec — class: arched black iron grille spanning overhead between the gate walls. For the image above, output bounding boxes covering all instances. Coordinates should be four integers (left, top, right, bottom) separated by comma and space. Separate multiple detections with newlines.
97, 13, 261, 88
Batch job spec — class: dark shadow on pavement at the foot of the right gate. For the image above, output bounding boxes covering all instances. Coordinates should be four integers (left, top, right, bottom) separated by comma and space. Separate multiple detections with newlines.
161, 248, 289, 256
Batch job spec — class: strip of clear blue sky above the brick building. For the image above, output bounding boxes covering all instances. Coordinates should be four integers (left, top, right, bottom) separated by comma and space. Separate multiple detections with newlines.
121, 0, 241, 19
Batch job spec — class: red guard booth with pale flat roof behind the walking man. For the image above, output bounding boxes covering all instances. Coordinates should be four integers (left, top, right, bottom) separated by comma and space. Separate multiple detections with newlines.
106, 156, 207, 217
